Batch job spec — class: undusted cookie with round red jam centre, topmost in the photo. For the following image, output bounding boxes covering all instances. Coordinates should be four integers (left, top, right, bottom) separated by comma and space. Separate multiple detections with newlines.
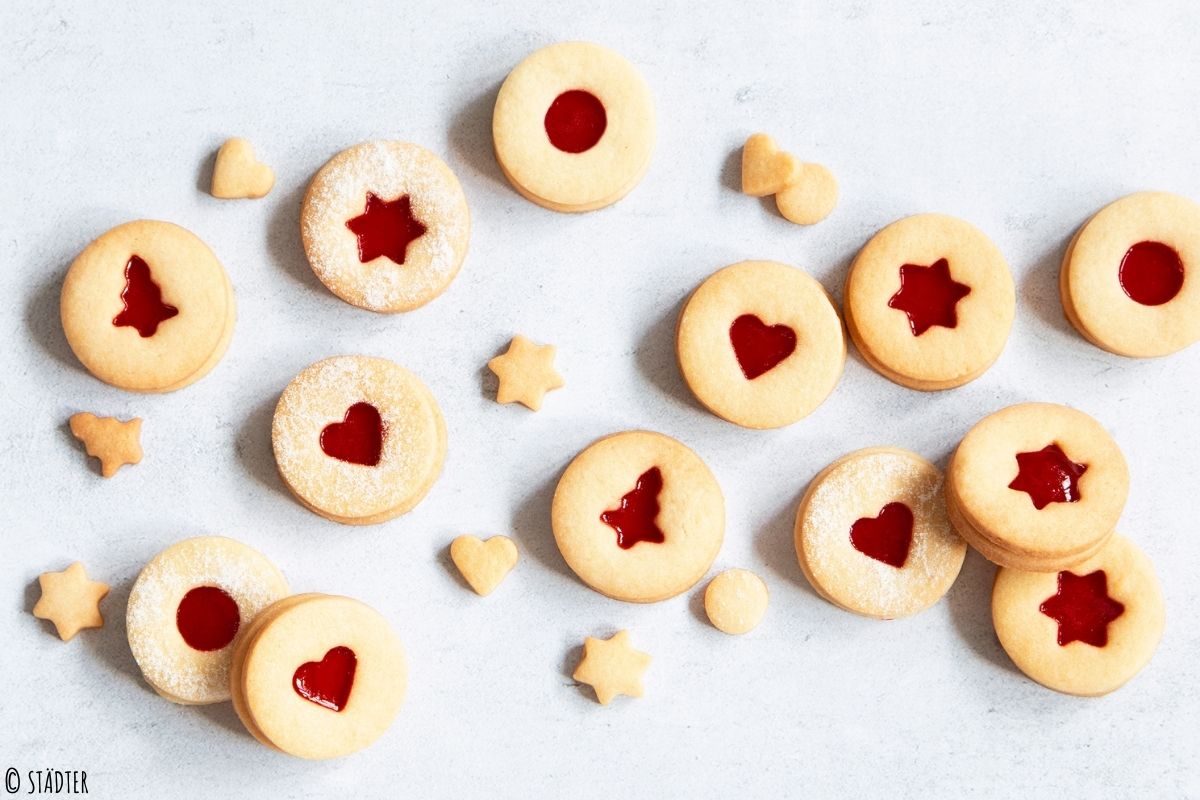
492, 42, 655, 211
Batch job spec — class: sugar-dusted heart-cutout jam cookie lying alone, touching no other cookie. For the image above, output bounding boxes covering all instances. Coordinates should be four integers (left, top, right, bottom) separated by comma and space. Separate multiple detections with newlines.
271, 355, 446, 525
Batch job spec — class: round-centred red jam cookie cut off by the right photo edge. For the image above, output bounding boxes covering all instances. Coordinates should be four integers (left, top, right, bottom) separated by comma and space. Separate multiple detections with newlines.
1058, 192, 1200, 357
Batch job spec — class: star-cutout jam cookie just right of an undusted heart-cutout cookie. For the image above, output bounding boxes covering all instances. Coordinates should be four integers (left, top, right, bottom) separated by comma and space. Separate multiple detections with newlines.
845, 213, 1016, 391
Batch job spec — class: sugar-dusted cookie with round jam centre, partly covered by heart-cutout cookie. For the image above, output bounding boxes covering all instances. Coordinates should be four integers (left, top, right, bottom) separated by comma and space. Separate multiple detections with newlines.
125, 536, 288, 704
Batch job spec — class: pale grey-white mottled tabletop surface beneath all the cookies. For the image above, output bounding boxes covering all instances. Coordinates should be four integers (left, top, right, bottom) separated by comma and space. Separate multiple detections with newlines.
0, 0, 1200, 798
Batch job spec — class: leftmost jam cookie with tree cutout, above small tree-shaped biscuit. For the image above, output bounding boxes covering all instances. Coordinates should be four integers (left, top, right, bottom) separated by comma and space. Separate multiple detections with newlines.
60, 219, 236, 392
